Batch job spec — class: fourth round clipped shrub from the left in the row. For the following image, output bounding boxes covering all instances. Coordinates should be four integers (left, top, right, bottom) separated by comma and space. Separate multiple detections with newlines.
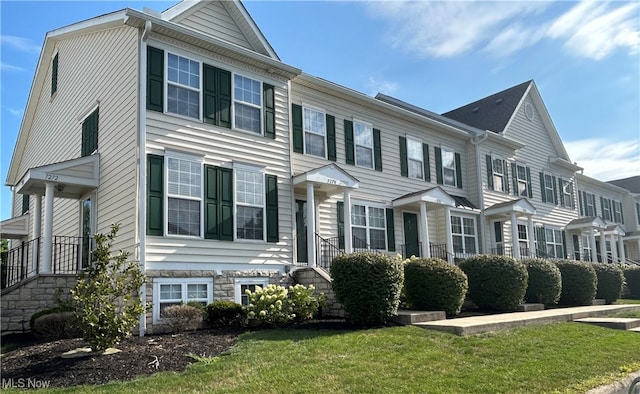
522, 259, 562, 305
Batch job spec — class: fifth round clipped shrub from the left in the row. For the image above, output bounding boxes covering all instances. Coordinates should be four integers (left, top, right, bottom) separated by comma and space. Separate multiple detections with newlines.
556, 260, 598, 305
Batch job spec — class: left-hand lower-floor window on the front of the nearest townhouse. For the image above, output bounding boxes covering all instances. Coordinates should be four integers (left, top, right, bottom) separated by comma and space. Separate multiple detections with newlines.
167, 156, 202, 237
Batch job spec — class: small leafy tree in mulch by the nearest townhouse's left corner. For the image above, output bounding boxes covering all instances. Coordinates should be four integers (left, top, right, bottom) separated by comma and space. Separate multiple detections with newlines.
71, 224, 147, 351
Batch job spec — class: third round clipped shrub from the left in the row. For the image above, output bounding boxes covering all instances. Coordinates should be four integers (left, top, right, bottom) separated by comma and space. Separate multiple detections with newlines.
460, 255, 528, 311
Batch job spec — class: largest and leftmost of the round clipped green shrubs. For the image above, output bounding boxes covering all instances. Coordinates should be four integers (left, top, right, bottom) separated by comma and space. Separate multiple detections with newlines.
331, 252, 404, 325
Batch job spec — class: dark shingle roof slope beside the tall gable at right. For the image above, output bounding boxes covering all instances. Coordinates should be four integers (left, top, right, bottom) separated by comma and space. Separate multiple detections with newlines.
442, 80, 533, 133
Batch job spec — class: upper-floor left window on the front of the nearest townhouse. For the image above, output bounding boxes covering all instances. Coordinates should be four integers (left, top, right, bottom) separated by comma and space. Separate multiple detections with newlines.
167, 53, 200, 119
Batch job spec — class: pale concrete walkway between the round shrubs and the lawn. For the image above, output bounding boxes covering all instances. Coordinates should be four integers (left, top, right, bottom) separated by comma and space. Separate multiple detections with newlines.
413, 304, 640, 335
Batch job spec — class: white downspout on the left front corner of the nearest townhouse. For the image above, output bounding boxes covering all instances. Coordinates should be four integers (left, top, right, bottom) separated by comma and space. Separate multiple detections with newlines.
138, 21, 152, 337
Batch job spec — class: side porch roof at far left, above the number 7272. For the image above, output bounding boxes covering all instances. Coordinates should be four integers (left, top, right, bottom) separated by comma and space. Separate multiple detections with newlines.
16, 154, 100, 199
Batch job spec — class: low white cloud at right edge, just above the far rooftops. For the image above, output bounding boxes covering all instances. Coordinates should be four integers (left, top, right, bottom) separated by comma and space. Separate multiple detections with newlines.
564, 138, 640, 181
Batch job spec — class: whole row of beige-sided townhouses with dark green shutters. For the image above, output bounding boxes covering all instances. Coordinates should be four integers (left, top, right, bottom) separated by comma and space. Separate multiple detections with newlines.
0, 0, 640, 333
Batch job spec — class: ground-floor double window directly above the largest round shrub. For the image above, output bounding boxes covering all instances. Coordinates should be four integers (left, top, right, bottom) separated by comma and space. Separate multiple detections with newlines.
351, 204, 387, 250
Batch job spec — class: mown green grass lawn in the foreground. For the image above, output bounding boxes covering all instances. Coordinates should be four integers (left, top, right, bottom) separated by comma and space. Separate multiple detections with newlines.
8, 323, 640, 394
